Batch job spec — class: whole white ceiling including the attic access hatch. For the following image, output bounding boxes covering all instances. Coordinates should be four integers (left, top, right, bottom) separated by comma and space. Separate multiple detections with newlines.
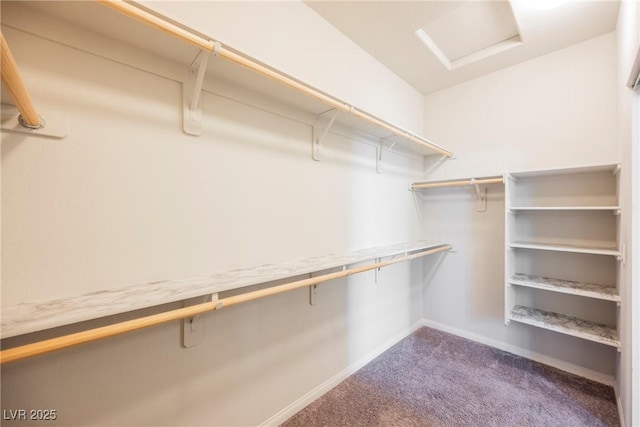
305, 0, 619, 94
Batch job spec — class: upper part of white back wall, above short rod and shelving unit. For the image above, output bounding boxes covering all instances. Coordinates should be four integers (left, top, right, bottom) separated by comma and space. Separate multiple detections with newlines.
425, 34, 617, 179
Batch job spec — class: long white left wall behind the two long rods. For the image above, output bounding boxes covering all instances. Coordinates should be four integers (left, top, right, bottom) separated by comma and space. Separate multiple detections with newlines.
1, 2, 430, 426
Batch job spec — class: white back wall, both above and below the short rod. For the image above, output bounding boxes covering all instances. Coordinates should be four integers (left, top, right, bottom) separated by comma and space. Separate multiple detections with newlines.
422, 34, 618, 382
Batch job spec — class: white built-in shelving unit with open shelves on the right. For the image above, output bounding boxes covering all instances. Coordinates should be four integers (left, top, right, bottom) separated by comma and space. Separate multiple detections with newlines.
505, 165, 624, 348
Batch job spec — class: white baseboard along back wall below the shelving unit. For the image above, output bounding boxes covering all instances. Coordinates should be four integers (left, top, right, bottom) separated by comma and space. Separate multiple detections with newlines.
421, 319, 615, 386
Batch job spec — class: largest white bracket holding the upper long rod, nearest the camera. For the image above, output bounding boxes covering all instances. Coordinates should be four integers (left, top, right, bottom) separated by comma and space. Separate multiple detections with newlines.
182, 48, 210, 136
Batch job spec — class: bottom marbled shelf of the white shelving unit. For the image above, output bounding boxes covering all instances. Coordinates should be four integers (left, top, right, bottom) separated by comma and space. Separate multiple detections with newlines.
509, 305, 620, 348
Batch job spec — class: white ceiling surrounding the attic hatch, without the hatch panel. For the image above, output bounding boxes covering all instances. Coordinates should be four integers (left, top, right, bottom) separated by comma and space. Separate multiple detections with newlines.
305, 0, 619, 94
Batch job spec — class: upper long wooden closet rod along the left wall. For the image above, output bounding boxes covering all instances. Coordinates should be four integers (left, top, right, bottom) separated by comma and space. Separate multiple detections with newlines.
95, 0, 453, 158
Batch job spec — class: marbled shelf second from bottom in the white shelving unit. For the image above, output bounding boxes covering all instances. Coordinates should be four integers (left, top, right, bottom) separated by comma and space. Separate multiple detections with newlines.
509, 273, 620, 302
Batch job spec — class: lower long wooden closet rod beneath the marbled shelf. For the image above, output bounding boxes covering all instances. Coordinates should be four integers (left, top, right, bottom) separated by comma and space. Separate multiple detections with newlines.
0, 244, 452, 364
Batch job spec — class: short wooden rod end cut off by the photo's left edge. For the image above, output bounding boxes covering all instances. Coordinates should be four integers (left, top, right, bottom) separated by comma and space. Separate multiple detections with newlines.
0, 32, 43, 129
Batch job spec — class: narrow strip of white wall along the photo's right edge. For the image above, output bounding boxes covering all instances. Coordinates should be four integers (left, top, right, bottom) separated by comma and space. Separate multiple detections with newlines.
616, 1, 640, 426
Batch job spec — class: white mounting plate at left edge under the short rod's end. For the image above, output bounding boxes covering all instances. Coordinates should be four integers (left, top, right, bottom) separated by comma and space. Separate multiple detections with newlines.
0, 104, 69, 139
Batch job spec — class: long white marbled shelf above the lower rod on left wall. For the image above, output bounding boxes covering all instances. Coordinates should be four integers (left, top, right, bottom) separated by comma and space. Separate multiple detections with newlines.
0, 241, 445, 338
